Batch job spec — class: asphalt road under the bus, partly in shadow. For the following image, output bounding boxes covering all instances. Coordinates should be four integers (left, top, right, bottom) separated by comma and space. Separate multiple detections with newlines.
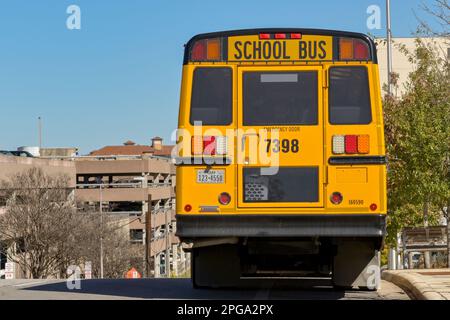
0, 279, 408, 300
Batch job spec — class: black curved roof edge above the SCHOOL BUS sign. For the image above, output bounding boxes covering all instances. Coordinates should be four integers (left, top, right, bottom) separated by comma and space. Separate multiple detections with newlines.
183, 28, 378, 64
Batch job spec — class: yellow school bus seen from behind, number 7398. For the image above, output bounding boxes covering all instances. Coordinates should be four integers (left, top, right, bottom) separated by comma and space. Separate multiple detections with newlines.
176, 29, 386, 289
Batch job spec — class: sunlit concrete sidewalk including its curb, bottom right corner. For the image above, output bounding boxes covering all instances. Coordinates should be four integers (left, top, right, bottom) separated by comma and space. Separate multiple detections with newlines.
381, 269, 450, 300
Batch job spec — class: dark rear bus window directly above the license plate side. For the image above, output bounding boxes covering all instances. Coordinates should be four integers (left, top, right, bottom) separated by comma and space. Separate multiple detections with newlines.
190, 67, 233, 126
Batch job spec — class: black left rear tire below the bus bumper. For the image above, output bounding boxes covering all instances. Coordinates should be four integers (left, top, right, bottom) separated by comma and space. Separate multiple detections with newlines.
191, 245, 241, 289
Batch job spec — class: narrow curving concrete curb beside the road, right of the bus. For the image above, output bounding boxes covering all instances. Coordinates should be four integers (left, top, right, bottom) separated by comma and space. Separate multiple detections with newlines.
381, 271, 446, 300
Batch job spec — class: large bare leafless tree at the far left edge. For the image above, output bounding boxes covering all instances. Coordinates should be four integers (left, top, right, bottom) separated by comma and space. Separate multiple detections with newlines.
0, 168, 80, 278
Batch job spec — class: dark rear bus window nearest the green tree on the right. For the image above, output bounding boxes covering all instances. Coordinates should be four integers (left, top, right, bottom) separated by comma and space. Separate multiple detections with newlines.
329, 67, 372, 124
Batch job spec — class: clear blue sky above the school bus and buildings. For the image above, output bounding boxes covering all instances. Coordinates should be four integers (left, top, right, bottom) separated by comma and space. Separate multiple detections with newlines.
0, 0, 442, 154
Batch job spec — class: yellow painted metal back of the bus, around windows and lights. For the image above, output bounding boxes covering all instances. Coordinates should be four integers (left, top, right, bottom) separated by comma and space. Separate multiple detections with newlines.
177, 61, 387, 215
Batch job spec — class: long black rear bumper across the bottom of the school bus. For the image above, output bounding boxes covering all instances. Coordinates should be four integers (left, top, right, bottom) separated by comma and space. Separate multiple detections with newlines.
176, 214, 386, 238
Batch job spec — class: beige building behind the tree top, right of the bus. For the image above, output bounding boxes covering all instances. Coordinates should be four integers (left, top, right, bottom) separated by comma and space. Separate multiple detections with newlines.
375, 38, 450, 96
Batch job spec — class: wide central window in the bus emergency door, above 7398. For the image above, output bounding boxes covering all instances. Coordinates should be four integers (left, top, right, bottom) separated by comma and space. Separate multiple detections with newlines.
243, 71, 318, 126
